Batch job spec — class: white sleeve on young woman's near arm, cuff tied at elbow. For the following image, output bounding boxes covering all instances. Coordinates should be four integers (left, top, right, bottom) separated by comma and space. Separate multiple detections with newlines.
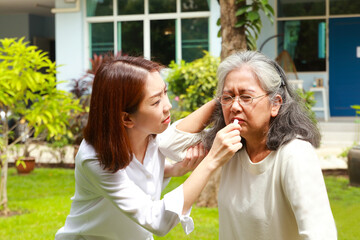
81, 160, 194, 236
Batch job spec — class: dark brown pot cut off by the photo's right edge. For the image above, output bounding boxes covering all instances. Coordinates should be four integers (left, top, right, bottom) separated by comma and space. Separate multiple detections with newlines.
348, 146, 360, 186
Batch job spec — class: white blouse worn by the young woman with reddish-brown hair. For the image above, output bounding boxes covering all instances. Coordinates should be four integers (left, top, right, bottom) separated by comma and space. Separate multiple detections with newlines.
55, 124, 200, 240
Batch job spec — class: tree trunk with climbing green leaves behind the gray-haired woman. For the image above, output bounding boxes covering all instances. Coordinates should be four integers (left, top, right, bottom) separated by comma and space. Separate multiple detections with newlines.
197, 0, 274, 207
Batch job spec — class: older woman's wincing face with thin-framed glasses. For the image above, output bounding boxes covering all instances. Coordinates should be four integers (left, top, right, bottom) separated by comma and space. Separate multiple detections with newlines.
222, 66, 279, 140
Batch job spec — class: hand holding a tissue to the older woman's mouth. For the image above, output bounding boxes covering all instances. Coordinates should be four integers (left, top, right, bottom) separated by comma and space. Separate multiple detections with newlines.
206, 123, 242, 168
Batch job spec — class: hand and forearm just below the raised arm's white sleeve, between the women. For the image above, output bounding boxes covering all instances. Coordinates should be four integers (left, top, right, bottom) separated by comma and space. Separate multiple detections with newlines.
164, 143, 208, 177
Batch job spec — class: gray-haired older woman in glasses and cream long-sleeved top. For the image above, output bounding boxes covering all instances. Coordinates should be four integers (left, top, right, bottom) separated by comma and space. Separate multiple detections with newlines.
164, 51, 337, 240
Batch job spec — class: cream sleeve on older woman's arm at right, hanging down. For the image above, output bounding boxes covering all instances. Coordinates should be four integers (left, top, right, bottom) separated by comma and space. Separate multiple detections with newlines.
282, 141, 337, 240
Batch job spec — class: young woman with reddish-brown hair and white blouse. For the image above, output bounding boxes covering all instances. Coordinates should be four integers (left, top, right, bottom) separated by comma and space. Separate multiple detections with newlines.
55, 57, 242, 240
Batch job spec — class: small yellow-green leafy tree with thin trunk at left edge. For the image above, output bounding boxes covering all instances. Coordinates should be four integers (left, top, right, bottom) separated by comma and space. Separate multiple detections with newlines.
0, 38, 80, 214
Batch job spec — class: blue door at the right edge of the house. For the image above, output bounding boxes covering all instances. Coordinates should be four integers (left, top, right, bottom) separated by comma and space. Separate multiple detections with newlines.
329, 17, 360, 116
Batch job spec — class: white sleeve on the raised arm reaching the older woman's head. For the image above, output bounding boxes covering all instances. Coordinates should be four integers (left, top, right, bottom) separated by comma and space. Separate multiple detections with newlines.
159, 120, 202, 162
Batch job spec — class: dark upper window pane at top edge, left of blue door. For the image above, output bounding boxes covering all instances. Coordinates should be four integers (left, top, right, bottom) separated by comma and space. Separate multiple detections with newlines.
278, 0, 326, 17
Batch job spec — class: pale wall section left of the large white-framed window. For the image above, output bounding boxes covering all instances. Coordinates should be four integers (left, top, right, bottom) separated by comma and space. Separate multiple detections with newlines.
55, 0, 86, 90
